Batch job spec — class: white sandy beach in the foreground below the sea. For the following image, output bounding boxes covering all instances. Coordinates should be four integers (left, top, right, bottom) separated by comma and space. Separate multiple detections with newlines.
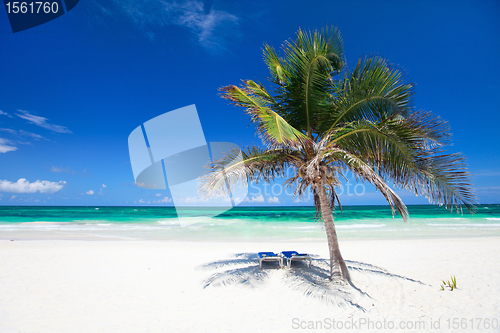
0, 237, 500, 332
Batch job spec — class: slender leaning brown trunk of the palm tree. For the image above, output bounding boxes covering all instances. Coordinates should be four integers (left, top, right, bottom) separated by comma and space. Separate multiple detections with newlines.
317, 181, 351, 281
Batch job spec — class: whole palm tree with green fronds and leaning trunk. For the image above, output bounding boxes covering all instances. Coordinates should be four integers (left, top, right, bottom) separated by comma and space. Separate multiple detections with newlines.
200, 27, 475, 281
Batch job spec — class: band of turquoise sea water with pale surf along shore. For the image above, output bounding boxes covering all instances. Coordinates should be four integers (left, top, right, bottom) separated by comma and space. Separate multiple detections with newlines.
0, 205, 500, 241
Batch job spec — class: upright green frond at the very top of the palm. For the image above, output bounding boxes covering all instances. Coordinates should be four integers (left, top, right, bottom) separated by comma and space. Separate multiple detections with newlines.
264, 24, 345, 137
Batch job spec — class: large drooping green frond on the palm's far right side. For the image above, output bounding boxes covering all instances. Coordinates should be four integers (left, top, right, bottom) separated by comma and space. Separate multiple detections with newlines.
324, 112, 476, 212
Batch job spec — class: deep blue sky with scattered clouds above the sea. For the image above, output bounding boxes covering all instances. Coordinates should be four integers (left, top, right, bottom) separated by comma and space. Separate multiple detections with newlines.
0, 0, 500, 205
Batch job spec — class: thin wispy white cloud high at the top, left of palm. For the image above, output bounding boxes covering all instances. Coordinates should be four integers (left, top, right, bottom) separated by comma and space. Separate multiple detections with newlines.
107, 0, 239, 48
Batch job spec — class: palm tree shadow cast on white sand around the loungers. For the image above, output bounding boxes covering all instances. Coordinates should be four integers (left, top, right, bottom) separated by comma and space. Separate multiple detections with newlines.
199, 253, 427, 311
